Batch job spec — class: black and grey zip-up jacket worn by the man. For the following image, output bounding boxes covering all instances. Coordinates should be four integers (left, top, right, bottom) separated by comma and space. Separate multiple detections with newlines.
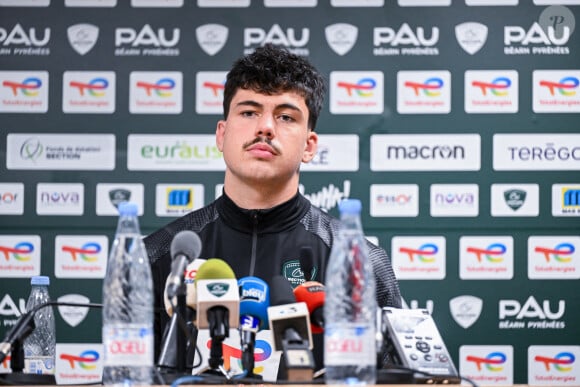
145, 193, 401, 364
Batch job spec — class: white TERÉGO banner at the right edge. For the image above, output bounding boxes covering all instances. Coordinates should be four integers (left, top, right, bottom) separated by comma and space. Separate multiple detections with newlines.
493, 133, 580, 171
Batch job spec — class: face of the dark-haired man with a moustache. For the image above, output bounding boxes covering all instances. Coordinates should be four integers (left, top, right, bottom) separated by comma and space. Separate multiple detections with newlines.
216, 89, 318, 183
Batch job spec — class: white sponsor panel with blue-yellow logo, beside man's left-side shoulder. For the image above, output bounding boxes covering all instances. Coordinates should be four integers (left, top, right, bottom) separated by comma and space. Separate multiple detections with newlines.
155, 184, 205, 217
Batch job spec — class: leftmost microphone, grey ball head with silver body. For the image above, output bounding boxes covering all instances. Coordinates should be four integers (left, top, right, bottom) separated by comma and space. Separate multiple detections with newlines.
165, 230, 201, 299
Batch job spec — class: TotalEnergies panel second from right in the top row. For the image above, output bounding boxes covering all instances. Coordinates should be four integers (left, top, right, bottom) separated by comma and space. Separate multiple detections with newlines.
464, 70, 519, 113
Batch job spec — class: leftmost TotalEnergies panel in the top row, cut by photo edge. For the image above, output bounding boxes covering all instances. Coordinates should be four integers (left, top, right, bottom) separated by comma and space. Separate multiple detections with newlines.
0, 71, 48, 113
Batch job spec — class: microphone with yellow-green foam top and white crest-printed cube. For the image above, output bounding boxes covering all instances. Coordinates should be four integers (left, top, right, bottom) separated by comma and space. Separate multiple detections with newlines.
195, 258, 240, 379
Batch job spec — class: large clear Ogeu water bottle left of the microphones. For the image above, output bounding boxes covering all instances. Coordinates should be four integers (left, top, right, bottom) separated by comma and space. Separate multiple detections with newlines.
103, 202, 154, 386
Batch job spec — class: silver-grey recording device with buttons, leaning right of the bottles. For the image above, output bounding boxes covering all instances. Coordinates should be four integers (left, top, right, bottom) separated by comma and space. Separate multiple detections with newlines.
382, 307, 460, 384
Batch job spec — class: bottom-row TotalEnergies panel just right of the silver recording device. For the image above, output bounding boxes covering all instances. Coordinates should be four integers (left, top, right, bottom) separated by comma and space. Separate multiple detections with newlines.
459, 345, 514, 386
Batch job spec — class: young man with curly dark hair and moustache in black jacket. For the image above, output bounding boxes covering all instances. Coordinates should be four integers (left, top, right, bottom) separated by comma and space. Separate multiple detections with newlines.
145, 45, 401, 372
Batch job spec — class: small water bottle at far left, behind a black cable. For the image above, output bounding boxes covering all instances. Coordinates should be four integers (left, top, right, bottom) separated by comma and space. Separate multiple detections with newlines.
23, 275, 56, 374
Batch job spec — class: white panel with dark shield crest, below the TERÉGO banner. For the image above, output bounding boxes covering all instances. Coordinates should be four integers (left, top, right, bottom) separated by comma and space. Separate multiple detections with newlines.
491, 184, 540, 216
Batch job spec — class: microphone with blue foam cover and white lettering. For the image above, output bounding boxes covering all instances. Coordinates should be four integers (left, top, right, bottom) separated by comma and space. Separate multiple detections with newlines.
238, 276, 270, 377
